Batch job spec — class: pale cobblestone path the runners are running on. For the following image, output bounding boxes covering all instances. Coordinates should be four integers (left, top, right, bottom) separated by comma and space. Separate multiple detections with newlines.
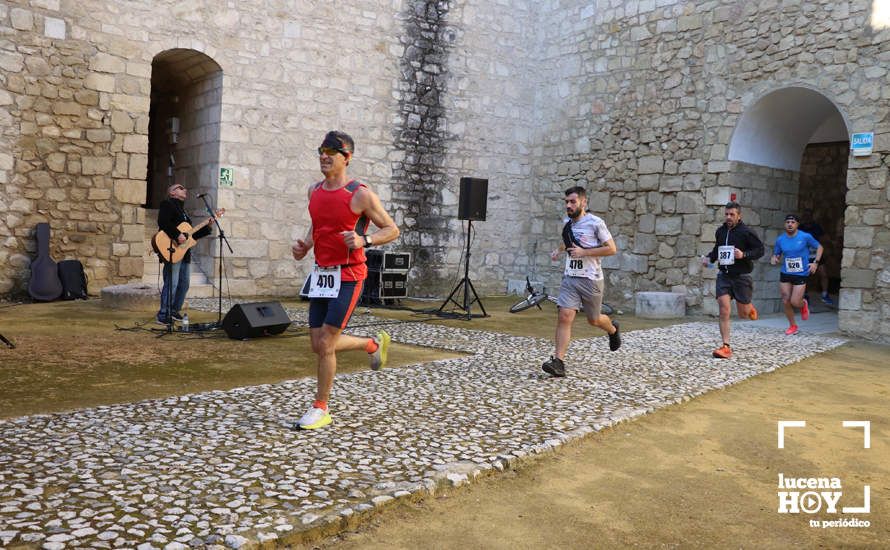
0, 305, 844, 550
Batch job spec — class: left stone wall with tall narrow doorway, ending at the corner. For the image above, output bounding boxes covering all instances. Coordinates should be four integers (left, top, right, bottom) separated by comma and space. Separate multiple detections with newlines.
0, 0, 534, 295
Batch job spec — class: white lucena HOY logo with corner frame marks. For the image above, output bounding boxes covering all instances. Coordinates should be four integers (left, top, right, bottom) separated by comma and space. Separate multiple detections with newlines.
778, 420, 871, 514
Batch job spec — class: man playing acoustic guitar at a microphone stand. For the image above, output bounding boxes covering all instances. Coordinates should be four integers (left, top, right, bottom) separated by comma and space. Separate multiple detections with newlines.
157, 183, 212, 325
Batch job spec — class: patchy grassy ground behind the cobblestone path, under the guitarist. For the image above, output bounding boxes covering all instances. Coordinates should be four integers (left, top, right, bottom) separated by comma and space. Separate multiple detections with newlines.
0, 297, 680, 417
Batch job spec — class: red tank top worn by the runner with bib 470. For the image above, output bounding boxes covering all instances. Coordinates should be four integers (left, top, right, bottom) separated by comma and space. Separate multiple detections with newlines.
309, 180, 368, 281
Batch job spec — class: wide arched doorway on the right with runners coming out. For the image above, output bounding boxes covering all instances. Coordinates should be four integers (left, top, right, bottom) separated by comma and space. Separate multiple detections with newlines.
729, 86, 849, 312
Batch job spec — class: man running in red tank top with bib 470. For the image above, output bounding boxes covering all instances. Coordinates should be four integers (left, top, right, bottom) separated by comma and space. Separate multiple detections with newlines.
292, 131, 399, 430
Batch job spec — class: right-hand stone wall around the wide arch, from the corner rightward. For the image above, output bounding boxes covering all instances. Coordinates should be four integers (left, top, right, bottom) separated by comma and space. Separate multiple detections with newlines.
515, 0, 890, 339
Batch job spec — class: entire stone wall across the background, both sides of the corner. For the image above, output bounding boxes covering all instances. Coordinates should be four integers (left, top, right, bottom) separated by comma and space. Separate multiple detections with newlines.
0, 0, 890, 339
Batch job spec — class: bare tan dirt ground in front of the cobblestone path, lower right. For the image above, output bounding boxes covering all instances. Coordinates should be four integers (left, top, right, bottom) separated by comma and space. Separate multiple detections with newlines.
320, 342, 890, 550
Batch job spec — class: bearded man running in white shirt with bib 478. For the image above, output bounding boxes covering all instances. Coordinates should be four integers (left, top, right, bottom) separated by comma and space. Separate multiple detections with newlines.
541, 186, 621, 377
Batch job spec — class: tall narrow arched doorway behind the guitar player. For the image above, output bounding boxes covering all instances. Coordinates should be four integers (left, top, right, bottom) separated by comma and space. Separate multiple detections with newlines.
143, 48, 223, 297
